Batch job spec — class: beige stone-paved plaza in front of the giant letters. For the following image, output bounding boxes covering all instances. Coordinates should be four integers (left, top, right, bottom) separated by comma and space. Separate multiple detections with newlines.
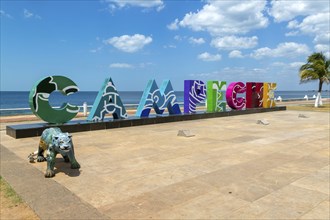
1, 111, 330, 219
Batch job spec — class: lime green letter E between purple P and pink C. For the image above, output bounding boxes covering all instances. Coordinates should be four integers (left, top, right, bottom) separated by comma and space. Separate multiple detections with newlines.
206, 81, 226, 112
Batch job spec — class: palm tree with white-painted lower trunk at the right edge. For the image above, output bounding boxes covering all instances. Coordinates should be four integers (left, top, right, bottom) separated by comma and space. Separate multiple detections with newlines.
299, 52, 330, 107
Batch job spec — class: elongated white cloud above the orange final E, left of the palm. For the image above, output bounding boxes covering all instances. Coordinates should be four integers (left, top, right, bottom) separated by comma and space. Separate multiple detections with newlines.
251, 42, 310, 59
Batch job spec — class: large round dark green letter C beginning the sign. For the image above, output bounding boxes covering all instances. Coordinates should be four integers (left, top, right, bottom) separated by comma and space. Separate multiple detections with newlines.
29, 76, 79, 124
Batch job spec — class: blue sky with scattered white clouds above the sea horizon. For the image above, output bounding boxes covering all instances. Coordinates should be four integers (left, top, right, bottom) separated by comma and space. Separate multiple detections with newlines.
0, 0, 330, 91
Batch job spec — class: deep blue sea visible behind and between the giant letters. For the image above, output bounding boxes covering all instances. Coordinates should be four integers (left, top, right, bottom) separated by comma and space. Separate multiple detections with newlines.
0, 91, 330, 116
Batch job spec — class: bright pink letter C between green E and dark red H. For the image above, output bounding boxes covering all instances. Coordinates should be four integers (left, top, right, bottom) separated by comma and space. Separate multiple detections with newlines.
226, 82, 246, 110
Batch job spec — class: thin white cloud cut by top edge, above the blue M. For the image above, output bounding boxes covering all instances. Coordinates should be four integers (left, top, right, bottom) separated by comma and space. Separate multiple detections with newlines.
105, 0, 165, 11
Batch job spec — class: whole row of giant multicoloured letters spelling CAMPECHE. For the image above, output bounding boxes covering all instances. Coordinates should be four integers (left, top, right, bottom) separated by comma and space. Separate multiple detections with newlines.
29, 76, 276, 124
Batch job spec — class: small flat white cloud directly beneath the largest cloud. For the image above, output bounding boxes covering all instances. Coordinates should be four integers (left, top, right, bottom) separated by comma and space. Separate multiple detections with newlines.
211, 36, 258, 50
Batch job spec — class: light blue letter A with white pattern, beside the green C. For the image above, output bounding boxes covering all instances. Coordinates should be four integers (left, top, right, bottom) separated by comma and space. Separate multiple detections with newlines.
87, 78, 128, 121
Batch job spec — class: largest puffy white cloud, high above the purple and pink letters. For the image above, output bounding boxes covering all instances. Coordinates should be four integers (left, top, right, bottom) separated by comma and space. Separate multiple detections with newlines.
171, 0, 268, 36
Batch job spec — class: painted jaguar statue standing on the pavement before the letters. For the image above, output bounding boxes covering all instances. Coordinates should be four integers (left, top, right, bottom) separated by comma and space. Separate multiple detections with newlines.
28, 127, 80, 178
